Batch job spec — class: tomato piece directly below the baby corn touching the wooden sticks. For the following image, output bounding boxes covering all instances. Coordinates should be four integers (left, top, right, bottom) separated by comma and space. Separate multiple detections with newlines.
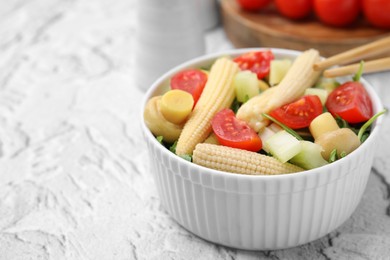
270, 95, 323, 129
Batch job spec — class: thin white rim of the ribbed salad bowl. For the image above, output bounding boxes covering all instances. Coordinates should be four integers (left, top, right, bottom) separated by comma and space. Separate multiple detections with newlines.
140, 47, 387, 181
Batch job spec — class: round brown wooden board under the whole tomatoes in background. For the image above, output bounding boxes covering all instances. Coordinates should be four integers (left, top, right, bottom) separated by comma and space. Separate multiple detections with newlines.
221, 0, 390, 57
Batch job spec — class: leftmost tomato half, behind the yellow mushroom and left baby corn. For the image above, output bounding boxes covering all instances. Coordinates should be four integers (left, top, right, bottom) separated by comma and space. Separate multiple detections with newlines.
171, 69, 207, 106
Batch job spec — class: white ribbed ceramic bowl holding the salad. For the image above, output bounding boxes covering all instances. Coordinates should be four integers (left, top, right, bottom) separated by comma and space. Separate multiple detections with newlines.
142, 49, 383, 250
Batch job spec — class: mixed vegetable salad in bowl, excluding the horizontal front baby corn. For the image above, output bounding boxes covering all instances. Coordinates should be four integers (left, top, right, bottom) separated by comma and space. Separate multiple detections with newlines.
144, 50, 385, 175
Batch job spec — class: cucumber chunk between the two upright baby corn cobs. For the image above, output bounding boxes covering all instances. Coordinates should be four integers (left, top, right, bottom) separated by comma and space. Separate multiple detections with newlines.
233, 70, 259, 103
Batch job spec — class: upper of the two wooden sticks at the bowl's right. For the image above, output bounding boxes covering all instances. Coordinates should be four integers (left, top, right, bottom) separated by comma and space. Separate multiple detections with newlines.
313, 36, 390, 70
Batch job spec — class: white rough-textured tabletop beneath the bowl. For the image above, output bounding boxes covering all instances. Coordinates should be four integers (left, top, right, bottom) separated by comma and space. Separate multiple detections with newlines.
0, 0, 390, 260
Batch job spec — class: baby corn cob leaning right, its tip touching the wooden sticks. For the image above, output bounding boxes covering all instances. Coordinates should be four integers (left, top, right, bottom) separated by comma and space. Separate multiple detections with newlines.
237, 49, 321, 132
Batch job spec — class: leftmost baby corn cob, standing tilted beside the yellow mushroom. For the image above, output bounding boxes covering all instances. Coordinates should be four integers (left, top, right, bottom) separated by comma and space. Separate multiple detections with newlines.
176, 58, 239, 155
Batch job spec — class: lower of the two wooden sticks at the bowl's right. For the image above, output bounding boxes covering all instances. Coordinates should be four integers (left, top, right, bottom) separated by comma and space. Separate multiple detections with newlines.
324, 57, 390, 78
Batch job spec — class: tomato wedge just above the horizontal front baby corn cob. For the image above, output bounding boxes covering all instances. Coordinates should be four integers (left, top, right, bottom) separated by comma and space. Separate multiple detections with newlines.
211, 109, 263, 152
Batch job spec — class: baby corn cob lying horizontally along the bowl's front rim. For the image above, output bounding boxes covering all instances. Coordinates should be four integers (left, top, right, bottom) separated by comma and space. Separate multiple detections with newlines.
192, 143, 303, 175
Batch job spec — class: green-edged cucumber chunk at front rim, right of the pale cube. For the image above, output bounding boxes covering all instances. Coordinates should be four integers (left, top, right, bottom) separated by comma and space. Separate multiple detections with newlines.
290, 141, 328, 170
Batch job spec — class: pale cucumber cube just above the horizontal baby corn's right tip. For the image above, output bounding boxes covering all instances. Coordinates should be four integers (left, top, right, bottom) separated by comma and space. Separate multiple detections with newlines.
264, 130, 302, 163
